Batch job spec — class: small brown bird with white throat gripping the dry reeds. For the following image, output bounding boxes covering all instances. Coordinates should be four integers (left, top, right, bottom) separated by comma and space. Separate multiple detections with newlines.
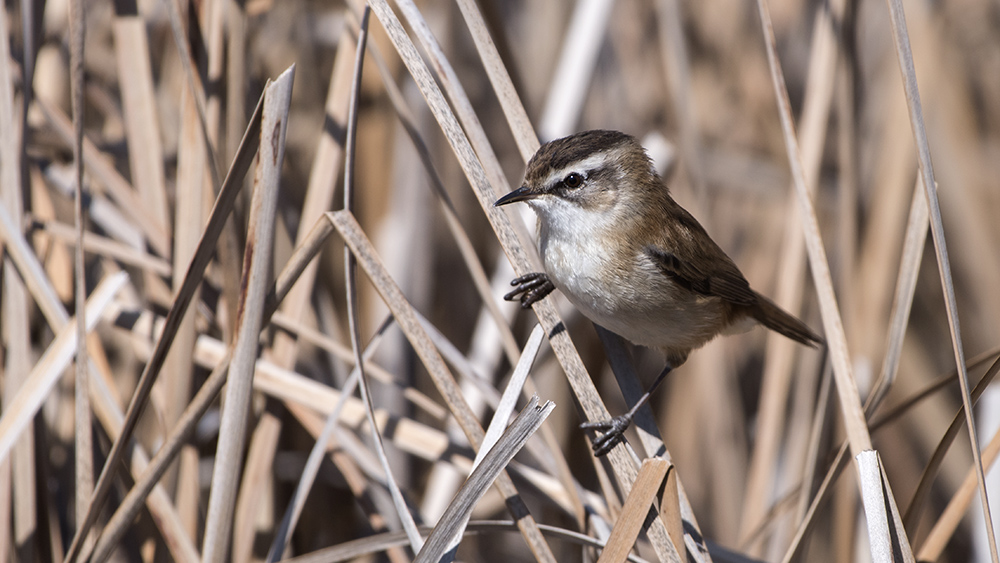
494, 131, 823, 455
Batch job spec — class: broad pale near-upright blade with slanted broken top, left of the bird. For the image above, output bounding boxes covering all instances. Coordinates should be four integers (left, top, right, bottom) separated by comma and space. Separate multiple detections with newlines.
201, 62, 295, 562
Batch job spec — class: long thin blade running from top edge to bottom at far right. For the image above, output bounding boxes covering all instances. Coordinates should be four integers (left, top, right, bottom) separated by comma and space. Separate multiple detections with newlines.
886, 0, 1000, 563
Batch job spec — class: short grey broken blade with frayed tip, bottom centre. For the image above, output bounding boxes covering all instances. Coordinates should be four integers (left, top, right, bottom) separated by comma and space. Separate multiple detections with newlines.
414, 397, 556, 563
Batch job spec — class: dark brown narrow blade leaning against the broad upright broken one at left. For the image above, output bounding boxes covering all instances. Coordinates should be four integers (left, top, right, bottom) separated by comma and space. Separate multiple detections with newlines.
62, 75, 263, 562
